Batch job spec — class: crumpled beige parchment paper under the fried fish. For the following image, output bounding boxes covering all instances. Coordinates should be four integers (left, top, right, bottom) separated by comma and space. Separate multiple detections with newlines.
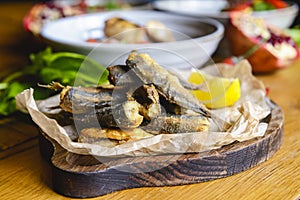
16, 60, 271, 157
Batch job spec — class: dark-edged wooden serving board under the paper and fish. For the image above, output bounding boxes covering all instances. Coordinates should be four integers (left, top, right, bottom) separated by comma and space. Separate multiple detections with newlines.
39, 101, 284, 198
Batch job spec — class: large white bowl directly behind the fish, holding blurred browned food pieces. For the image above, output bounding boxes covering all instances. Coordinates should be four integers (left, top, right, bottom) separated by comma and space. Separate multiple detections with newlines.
41, 10, 224, 68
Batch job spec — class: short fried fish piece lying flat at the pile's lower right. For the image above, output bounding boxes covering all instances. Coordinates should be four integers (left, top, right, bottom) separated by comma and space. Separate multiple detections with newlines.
142, 114, 210, 135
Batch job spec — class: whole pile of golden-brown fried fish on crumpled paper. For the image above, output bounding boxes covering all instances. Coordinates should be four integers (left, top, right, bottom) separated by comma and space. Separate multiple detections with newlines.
56, 51, 225, 147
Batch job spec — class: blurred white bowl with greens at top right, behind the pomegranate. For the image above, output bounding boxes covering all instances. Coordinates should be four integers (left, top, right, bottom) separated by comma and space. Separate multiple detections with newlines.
152, 0, 299, 28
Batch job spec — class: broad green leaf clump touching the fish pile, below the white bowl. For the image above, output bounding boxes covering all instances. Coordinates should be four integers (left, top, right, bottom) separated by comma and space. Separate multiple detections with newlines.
31, 50, 108, 86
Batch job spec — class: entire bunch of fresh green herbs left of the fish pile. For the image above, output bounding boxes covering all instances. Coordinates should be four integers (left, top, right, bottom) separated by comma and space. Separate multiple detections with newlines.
0, 48, 108, 116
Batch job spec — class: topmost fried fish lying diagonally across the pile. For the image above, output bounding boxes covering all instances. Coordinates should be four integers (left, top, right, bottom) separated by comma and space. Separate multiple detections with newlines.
126, 51, 211, 117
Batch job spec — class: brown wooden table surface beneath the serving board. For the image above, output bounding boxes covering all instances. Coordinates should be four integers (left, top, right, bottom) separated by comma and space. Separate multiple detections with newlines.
0, 1, 300, 200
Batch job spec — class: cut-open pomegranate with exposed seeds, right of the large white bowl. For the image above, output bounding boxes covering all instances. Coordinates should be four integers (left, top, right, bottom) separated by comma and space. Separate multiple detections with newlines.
226, 12, 300, 72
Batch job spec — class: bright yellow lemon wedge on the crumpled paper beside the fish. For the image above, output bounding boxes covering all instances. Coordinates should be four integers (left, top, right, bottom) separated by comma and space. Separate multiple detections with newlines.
188, 72, 241, 108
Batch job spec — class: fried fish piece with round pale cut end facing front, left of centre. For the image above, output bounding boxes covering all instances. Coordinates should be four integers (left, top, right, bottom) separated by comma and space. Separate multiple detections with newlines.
73, 100, 143, 128
